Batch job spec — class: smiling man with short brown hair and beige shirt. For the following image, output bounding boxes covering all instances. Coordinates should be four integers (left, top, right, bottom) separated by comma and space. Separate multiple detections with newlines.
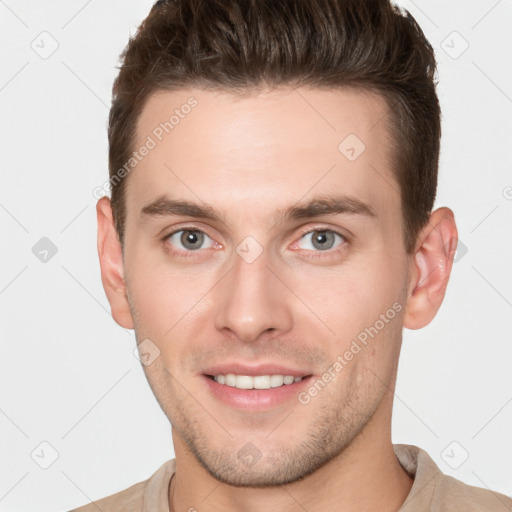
72, 0, 512, 512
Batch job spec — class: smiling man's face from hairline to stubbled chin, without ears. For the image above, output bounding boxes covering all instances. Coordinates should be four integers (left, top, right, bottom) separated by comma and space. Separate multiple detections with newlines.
120, 88, 409, 486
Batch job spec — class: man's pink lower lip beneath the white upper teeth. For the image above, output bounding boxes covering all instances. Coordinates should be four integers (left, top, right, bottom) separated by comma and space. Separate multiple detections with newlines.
202, 375, 312, 411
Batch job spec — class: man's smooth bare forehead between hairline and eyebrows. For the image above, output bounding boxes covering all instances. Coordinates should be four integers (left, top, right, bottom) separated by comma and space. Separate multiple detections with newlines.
126, 87, 399, 224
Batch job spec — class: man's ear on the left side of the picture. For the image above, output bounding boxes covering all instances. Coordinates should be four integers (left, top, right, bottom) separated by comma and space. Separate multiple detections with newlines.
96, 197, 133, 329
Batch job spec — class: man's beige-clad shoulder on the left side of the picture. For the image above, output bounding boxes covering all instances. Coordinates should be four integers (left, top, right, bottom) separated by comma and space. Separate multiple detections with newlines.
69, 459, 175, 512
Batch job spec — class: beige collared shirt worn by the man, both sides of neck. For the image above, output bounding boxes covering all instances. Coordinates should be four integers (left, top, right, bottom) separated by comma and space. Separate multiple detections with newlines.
70, 444, 512, 512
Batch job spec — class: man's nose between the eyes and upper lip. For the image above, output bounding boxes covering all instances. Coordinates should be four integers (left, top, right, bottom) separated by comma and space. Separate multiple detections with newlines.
215, 245, 293, 343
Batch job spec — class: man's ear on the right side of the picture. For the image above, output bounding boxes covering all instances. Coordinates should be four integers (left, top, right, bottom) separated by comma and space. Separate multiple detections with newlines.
404, 207, 458, 329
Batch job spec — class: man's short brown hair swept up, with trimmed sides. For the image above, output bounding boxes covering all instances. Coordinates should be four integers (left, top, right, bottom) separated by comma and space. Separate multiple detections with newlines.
108, 0, 441, 254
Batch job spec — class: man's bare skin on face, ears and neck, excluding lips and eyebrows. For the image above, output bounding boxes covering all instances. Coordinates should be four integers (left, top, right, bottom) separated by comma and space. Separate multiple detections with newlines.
97, 87, 457, 512
